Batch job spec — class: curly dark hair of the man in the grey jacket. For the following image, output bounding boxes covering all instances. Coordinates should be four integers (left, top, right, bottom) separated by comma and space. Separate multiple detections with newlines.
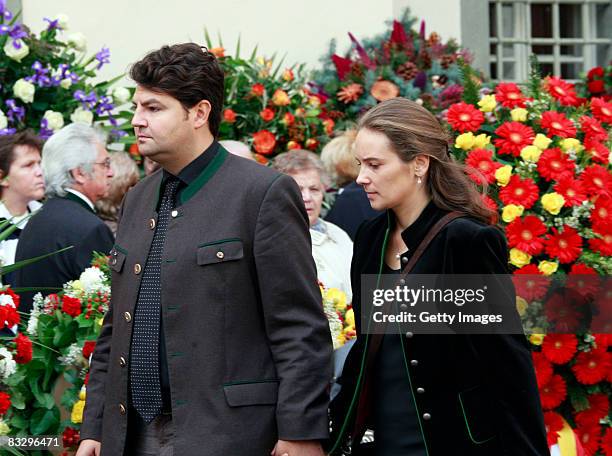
130, 43, 224, 138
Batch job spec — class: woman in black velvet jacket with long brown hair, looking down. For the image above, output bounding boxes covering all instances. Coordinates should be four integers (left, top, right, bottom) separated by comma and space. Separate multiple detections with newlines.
336, 98, 549, 456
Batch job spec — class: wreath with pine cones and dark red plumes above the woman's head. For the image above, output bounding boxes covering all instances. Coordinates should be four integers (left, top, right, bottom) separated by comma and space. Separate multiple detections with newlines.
312, 10, 471, 129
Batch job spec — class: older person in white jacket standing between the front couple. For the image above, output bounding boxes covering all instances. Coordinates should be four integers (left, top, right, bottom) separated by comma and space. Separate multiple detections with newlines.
273, 149, 353, 302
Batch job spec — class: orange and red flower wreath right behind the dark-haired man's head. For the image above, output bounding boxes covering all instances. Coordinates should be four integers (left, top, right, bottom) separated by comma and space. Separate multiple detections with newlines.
206, 35, 334, 163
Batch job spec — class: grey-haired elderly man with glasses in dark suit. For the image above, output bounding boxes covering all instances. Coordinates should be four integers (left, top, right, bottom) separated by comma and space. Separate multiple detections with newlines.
15, 123, 113, 312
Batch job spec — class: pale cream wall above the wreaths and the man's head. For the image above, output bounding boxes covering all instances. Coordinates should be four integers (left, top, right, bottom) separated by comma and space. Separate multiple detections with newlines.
21, 0, 400, 83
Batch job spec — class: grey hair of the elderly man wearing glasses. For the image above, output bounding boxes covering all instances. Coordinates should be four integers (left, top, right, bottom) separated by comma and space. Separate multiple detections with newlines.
41, 123, 106, 197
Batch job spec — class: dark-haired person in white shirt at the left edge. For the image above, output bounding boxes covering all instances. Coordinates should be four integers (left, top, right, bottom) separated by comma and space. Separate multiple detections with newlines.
0, 131, 45, 278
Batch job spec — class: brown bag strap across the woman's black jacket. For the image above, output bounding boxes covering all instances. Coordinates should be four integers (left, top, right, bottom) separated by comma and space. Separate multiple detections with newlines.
352, 211, 465, 442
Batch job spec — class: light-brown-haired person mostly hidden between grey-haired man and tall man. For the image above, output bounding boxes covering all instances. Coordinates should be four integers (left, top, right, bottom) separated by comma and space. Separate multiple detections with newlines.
95, 152, 140, 234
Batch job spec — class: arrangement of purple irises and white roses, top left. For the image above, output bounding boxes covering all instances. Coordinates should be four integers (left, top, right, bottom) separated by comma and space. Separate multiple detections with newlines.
0, 4, 131, 138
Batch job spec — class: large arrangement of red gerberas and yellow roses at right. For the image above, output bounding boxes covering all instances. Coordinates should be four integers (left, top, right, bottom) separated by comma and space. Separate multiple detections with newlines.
446, 58, 612, 455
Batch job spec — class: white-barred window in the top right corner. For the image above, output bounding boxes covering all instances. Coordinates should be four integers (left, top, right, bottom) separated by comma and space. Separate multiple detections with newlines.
489, 0, 612, 82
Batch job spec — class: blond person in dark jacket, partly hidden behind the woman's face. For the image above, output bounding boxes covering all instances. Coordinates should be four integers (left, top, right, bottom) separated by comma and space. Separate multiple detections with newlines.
321, 130, 381, 240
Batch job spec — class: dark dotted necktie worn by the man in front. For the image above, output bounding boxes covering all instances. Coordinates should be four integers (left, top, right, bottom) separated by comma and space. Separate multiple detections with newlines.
130, 176, 179, 423
